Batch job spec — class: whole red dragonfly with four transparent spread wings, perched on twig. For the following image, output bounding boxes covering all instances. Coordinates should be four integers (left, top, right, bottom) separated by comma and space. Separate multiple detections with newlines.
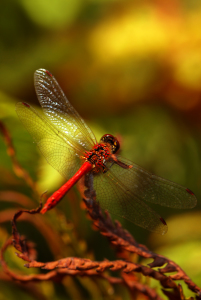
16, 69, 197, 234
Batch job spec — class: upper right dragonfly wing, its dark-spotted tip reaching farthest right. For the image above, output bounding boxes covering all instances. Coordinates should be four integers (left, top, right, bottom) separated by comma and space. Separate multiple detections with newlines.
111, 156, 197, 209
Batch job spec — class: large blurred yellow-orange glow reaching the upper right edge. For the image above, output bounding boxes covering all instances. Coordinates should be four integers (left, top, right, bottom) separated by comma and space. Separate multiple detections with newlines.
88, 6, 201, 89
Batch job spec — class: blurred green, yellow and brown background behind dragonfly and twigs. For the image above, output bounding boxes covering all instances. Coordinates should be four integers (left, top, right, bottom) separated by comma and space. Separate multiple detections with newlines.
0, 0, 201, 299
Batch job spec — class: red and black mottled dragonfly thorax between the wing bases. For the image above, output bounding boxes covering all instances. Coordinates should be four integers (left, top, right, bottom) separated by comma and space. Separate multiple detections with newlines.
84, 143, 112, 173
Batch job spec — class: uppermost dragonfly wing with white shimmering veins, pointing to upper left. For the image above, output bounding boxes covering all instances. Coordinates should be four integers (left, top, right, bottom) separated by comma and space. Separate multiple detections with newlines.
34, 69, 97, 150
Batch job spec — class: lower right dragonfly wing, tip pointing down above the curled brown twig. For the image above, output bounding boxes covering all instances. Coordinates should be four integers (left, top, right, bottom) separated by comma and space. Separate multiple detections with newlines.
94, 166, 168, 234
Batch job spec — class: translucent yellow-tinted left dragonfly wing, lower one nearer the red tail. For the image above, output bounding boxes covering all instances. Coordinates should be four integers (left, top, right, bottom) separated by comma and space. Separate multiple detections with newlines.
16, 102, 80, 179
